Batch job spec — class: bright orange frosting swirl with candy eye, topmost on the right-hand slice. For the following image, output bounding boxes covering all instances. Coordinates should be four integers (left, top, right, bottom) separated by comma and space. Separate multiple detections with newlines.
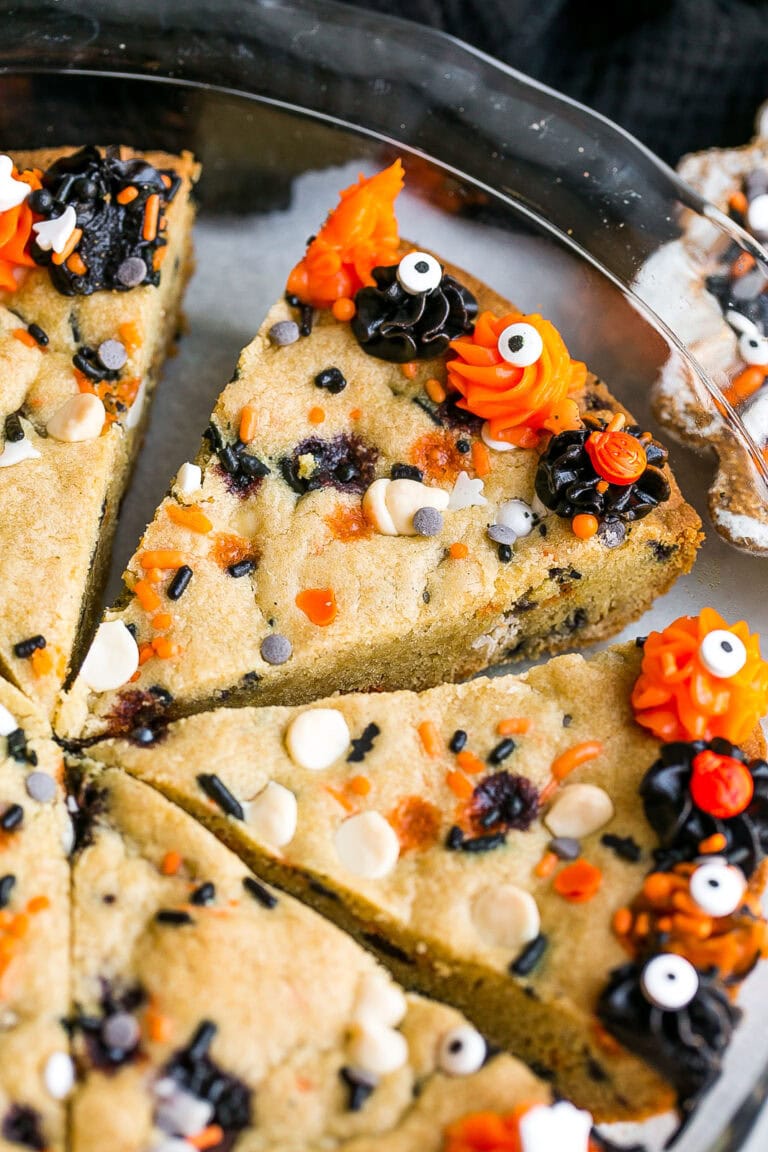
632, 608, 768, 744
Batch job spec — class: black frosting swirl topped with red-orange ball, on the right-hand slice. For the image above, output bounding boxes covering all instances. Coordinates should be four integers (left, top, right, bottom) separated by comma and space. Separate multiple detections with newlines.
640, 737, 768, 878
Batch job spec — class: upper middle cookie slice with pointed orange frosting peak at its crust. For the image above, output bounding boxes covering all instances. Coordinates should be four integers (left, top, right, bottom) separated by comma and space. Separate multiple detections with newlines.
60, 161, 700, 736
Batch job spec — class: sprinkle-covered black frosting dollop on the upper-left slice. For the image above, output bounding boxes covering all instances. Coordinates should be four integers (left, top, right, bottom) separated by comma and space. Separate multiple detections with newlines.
30, 145, 180, 296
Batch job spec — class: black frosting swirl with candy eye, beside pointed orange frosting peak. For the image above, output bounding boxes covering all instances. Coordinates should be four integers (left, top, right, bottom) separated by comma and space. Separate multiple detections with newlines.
351, 264, 478, 364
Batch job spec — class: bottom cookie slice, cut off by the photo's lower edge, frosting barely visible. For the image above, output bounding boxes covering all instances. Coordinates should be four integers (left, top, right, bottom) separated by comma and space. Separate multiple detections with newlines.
70, 770, 590, 1152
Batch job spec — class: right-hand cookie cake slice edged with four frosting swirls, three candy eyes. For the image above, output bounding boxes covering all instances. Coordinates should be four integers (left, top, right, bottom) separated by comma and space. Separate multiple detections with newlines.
90, 609, 768, 1121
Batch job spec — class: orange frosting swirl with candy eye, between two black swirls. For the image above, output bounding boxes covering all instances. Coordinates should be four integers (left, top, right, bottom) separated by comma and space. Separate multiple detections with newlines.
448, 312, 586, 448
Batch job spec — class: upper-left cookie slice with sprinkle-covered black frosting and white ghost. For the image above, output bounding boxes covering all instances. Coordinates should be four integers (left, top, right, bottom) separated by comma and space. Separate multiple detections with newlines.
0, 147, 197, 714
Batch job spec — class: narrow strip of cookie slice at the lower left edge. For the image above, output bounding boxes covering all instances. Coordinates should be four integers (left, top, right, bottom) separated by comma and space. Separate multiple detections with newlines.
0, 681, 73, 1152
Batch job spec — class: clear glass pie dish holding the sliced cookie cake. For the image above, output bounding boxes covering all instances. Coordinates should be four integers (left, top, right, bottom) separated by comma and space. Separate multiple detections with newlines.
0, 0, 768, 1152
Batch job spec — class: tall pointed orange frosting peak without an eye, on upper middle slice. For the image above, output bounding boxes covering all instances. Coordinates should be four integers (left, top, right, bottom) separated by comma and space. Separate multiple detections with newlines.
287, 160, 403, 308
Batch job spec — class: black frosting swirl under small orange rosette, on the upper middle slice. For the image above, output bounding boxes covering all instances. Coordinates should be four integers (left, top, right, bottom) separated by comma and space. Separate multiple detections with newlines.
535, 416, 670, 521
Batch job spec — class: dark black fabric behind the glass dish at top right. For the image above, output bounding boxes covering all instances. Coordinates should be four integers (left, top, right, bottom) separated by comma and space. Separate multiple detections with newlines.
356, 0, 768, 164
